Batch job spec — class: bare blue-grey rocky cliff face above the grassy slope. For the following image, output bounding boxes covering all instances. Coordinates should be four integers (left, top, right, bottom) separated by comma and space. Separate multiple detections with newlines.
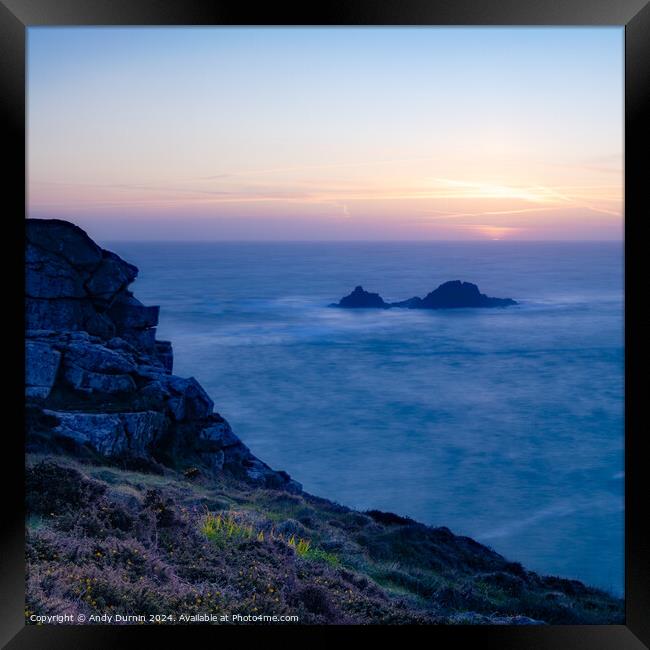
25, 219, 300, 491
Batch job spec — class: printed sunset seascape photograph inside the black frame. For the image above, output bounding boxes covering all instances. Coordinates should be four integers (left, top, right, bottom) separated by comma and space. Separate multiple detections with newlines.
25, 27, 625, 625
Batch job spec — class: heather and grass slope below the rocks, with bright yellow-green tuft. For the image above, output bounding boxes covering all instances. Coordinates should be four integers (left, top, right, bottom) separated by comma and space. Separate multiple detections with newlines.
26, 454, 623, 623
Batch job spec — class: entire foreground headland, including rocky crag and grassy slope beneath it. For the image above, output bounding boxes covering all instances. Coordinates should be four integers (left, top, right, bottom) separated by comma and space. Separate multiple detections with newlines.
25, 220, 623, 625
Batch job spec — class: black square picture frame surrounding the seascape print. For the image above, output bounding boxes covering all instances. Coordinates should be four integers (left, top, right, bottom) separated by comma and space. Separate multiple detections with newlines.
0, 0, 650, 650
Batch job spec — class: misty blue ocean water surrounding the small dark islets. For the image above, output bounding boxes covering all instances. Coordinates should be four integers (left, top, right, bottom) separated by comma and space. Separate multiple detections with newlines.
103, 241, 624, 595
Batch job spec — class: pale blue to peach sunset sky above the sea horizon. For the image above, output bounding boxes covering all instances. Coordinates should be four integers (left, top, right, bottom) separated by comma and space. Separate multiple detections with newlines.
27, 27, 624, 241
